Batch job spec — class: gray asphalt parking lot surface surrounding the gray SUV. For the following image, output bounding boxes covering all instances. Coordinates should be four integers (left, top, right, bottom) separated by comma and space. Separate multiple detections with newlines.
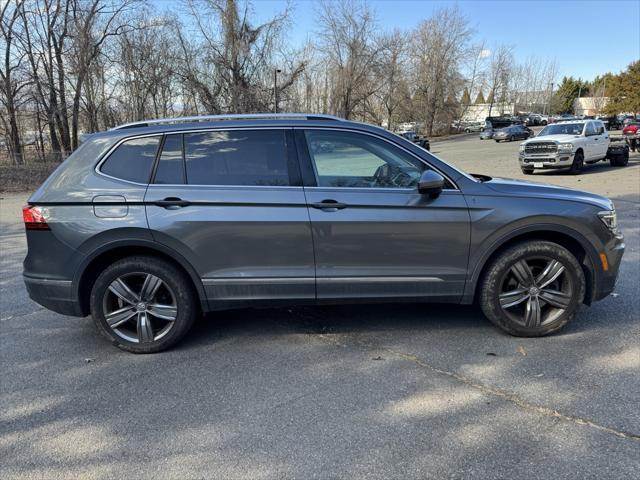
0, 134, 640, 479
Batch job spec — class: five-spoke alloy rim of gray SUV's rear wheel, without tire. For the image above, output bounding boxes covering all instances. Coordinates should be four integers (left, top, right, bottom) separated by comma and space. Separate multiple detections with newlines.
102, 272, 178, 343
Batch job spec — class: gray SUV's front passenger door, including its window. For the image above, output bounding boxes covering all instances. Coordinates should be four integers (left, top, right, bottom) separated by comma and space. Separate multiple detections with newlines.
296, 129, 470, 300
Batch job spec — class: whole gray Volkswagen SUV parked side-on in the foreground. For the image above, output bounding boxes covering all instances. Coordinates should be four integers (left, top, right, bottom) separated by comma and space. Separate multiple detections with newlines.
23, 114, 624, 353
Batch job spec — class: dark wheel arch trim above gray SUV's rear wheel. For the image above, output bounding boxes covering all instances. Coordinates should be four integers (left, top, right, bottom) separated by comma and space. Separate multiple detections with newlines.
73, 239, 209, 315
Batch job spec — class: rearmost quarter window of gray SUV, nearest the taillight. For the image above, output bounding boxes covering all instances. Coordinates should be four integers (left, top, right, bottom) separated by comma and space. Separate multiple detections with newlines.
100, 136, 160, 183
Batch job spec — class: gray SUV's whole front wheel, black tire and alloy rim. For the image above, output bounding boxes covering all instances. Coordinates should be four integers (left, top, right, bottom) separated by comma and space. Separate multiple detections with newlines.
480, 241, 586, 337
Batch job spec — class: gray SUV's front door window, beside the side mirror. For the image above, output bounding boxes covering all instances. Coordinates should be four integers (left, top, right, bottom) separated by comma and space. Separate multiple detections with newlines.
305, 130, 427, 188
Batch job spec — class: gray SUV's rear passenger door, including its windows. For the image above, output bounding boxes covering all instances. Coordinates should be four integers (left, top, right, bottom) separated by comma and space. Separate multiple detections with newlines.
145, 128, 315, 307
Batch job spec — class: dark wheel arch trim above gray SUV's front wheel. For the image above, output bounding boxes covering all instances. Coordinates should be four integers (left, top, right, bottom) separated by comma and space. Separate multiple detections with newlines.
462, 226, 598, 305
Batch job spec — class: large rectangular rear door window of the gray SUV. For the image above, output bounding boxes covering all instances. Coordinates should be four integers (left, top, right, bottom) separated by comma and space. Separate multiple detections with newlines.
184, 130, 290, 186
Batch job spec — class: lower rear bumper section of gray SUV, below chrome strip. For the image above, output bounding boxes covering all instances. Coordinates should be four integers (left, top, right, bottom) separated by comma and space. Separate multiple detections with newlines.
23, 275, 84, 317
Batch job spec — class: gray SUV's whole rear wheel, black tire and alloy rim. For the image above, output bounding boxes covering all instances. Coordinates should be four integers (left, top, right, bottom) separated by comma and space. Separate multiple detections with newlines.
90, 256, 198, 353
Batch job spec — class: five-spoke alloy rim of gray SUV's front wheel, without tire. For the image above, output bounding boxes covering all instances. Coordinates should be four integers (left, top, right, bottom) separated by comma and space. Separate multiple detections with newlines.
499, 257, 575, 328
